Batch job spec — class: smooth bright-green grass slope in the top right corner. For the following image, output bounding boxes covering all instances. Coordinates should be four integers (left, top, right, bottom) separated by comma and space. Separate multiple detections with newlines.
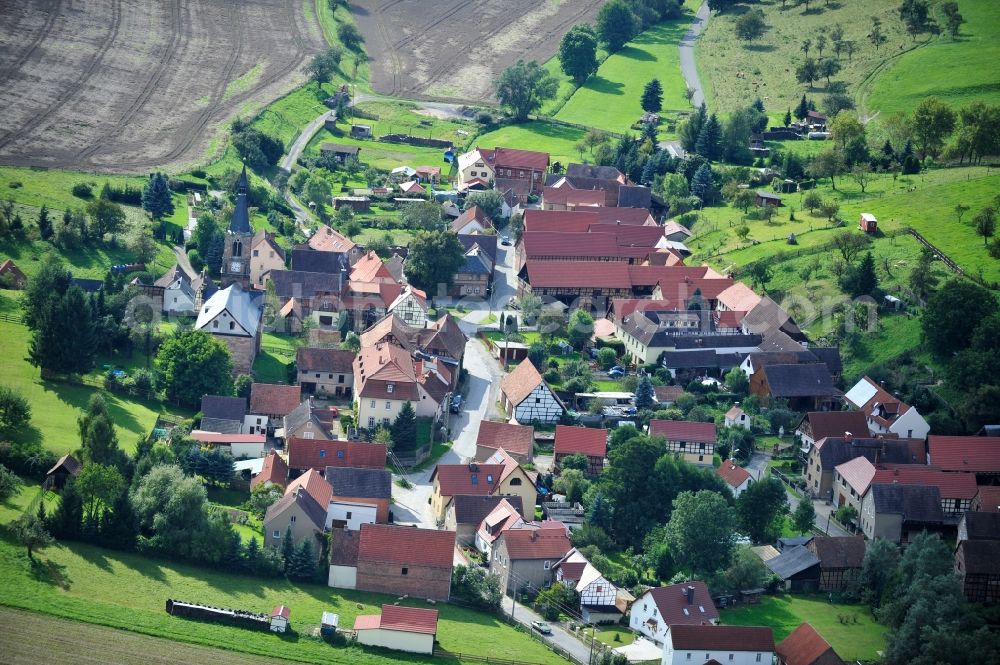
867, 0, 1000, 115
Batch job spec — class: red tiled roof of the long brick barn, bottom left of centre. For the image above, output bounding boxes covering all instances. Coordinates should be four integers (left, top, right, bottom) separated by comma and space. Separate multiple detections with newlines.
358, 524, 455, 570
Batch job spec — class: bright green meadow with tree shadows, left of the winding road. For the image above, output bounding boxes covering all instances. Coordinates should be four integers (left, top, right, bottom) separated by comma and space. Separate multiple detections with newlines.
555, 17, 691, 132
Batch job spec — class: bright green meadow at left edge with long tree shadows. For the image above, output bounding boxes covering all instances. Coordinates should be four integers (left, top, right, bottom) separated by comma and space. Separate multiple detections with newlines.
0, 291, 190, 455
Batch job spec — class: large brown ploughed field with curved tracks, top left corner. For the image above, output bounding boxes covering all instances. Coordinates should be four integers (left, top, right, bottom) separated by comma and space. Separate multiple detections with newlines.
0, 0, 325, 173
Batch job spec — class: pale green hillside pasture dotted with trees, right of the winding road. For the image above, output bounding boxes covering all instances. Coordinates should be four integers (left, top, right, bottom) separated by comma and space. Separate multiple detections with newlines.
695, 0, 913, 122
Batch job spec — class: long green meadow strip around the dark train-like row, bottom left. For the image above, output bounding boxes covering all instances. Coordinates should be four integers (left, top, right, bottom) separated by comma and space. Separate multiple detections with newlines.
0, 540, 564, 665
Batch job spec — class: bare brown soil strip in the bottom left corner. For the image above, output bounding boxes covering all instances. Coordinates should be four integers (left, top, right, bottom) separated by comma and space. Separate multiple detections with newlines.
0, 607, 298, 665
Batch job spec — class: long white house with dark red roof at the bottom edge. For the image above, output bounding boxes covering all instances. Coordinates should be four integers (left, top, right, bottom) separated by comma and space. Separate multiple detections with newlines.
662, 625, 774, 665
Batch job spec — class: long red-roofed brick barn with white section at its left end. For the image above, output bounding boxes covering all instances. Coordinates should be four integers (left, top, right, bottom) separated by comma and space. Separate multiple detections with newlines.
329, 524, 455, 601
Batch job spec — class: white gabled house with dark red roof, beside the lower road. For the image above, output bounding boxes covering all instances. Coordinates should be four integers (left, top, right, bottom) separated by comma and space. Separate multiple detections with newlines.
628, 580, 719, 645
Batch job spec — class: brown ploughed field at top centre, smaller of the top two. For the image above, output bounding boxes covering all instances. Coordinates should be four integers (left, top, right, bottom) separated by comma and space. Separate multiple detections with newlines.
351, 0, 605, 102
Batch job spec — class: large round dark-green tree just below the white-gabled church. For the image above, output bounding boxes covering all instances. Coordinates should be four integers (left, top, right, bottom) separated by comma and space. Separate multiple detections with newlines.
155, 330, 233, 407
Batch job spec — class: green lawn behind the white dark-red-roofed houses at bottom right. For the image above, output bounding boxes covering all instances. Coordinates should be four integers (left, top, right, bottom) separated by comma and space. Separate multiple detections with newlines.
719, 595, 886, 662
